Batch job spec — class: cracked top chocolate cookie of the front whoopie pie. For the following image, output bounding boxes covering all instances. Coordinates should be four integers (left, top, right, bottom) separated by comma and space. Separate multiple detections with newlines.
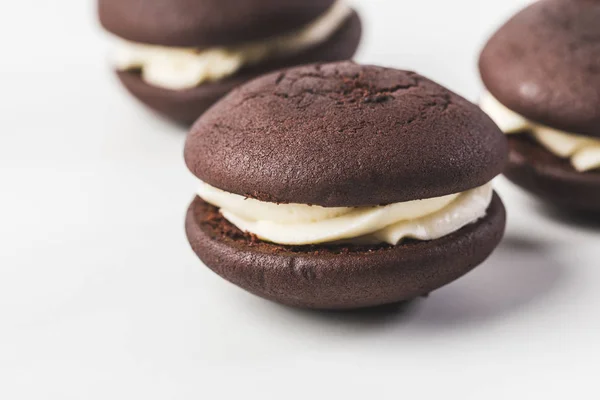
185, 62, 507, 207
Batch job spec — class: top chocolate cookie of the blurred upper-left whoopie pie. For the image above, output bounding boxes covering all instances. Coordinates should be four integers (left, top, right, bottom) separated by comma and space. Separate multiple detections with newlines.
98, 0, 335, 47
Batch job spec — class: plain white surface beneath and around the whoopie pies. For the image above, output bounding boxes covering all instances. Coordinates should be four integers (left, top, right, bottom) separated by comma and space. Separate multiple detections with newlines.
0, 0, 600, 400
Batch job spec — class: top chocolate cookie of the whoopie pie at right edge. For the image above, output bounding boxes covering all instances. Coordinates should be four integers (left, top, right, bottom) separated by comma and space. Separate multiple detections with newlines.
479, 0, 600, 137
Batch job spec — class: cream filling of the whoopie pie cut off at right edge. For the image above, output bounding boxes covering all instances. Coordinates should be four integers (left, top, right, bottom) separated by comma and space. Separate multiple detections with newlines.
480, 92, 600, 172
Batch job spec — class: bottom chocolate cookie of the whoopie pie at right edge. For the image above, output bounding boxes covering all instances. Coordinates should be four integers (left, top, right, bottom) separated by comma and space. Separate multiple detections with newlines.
504, 135, 600, 212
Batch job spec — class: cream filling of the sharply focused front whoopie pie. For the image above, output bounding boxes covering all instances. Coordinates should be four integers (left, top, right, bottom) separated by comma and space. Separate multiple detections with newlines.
198, 182, 493, 245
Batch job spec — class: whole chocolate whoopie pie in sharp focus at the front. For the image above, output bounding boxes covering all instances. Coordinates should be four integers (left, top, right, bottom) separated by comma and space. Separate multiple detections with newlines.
185, 62, 507, 309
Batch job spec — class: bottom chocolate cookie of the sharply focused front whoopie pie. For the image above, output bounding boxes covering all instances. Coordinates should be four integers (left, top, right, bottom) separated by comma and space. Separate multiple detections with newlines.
186, 195, 505, 309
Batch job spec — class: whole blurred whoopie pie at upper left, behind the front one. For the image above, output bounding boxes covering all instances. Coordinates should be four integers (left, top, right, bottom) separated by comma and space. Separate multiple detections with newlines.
99, 0, 361, 124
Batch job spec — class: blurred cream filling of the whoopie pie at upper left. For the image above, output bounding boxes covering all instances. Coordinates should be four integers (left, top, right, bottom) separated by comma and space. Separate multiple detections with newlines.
113, 0, 352, 90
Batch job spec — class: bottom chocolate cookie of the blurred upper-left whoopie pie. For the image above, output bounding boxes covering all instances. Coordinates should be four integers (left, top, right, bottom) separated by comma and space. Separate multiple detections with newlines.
117, 12, 362, 125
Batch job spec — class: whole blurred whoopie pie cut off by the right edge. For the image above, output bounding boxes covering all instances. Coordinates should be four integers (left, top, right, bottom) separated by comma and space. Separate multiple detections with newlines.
480, 0, 600, 212
